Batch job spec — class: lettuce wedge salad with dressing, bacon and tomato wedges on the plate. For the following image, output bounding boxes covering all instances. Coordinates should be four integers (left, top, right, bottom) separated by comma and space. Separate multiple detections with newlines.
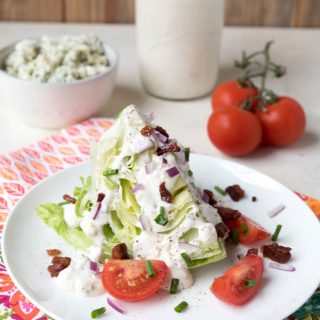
36, 105, 291, 312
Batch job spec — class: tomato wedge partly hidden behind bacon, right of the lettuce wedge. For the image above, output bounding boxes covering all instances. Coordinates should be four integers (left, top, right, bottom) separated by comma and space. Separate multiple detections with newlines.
226, 215, 271, 244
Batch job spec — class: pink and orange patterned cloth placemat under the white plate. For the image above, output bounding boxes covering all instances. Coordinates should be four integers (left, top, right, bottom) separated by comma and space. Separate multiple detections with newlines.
0, 118, 320, 320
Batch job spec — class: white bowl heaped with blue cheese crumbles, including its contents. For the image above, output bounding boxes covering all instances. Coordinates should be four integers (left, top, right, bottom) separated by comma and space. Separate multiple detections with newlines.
0, 34, 118, 128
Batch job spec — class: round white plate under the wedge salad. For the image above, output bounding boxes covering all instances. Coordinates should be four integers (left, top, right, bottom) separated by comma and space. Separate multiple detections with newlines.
3, 154, 320, 320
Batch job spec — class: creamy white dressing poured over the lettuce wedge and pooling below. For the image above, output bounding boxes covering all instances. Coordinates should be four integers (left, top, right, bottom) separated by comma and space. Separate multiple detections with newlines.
58, 106, 221, 295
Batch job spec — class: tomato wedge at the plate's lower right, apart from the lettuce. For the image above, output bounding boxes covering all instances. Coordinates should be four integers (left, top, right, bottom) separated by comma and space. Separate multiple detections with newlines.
211, 255, 263, 305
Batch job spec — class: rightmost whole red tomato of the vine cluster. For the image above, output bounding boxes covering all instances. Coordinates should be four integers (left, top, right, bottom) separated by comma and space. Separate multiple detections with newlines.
256, 97, 306, 147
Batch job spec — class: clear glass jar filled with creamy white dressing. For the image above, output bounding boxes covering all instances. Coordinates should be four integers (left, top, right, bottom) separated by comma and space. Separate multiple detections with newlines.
136, 0, 224, 100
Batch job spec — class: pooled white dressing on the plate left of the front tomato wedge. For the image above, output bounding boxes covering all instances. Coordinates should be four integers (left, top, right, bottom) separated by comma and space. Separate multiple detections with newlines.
55, 256, 104, 297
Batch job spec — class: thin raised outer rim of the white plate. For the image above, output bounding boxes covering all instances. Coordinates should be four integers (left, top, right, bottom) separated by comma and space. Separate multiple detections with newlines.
1, 152, 320, 320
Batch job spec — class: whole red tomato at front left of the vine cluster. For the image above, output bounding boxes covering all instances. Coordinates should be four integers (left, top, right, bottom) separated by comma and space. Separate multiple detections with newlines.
208, 108, 261, 156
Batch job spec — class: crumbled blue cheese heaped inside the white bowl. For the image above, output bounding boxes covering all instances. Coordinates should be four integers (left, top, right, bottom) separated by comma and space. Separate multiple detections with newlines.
5, 35, 109, 83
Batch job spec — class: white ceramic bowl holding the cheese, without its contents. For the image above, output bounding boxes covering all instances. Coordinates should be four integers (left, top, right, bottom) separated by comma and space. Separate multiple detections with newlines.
0, 40, 118, 128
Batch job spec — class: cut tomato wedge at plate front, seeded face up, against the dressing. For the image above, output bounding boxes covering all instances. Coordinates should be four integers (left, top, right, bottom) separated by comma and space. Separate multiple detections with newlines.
101, 259, 168, 301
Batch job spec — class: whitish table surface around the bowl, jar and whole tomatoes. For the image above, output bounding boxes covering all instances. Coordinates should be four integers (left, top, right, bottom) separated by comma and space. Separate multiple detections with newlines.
0, 22, 320, 197
